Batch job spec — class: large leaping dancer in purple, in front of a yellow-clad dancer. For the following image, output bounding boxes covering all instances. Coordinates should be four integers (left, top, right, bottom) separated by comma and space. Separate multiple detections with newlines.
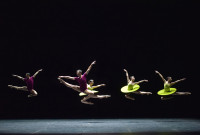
58, 61, 110, 105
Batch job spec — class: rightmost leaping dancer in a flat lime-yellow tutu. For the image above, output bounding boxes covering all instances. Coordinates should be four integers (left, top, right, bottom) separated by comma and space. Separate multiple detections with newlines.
155, 71, 191, 100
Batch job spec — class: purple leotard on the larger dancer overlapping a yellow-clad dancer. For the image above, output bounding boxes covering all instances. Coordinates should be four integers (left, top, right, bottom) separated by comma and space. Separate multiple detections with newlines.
75, 73, 87, 92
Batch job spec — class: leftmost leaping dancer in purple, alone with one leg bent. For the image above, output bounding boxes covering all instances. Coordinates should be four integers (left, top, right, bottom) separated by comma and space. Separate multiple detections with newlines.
8, 69, 42, 97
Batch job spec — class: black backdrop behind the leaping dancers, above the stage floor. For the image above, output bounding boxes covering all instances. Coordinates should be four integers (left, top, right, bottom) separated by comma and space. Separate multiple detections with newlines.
0, 0, 200, 119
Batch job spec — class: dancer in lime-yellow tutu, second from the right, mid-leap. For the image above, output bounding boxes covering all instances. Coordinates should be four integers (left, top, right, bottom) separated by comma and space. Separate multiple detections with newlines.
121, 69, 152, 100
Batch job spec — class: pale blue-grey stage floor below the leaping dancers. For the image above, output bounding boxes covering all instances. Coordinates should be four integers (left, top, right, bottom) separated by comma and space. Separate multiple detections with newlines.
0, 119, 200, 135
